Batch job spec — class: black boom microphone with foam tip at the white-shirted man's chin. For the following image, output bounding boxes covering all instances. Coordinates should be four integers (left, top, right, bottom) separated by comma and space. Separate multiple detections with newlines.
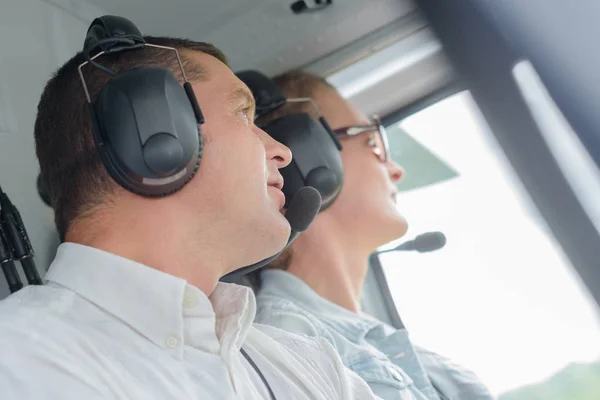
221, 186, 321, 282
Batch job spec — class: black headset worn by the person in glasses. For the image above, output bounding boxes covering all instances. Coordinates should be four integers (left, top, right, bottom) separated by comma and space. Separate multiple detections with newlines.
236, 70, 344, 211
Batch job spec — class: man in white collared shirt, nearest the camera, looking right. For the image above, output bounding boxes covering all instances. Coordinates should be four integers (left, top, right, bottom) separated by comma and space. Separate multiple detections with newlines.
0, 16, 382, 400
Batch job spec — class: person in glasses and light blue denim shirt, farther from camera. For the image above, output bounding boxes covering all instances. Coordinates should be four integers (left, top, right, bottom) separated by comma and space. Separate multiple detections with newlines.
251, 72, 493, 400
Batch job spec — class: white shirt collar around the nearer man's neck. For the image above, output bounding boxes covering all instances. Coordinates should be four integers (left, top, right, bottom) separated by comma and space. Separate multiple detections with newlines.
46, 243, 256, 358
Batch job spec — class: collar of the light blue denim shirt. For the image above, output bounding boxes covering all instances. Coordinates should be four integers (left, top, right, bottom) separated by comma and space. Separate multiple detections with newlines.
259, 269, 380, 340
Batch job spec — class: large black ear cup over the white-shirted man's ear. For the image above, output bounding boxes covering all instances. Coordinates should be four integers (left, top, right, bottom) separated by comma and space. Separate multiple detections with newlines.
95, 67, 201, 197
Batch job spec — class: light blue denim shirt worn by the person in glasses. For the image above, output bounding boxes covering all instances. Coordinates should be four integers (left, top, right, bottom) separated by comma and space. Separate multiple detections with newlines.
255, 270, 494, 400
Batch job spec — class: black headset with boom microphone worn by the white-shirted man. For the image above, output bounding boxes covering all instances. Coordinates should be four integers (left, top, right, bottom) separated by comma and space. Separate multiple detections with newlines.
78, 16, 321, 280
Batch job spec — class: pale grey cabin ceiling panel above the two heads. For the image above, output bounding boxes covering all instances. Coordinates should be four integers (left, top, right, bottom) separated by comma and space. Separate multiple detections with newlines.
72, 0, 414, 74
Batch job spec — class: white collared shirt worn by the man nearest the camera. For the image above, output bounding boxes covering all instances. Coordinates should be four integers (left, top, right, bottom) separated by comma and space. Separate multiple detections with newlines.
0, 243, 375, 400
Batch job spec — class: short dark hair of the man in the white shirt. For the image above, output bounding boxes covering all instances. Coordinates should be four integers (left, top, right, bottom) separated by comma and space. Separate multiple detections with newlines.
34, 36, 227, 242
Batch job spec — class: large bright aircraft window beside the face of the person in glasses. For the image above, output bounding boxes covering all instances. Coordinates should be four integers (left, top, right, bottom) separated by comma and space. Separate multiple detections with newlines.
380, 91, 600, 400
